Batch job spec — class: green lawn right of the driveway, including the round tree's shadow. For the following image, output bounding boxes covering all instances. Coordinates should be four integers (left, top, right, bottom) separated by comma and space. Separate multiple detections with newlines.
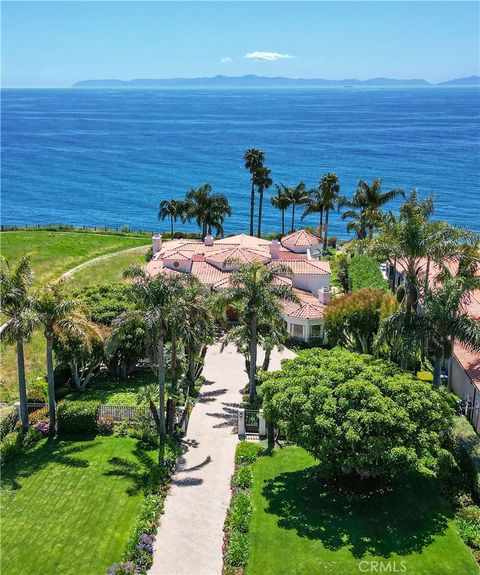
246, 447, 480, 575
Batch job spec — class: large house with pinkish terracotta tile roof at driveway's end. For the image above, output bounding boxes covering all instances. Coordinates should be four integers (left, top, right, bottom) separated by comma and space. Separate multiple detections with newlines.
147, 230, 332, 340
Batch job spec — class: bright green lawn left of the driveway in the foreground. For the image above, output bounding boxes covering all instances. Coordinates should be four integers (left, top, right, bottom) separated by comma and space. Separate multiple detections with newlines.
1, 436, 155, 575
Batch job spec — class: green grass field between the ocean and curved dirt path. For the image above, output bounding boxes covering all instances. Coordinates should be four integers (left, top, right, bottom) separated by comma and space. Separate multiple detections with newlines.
0, 230, 148, 285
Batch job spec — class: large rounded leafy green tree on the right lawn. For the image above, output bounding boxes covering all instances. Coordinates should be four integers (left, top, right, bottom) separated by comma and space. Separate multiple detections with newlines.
259, 348, 453, 477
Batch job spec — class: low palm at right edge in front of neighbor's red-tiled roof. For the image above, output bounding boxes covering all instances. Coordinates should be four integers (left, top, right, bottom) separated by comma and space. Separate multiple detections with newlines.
422, 272, 480, 389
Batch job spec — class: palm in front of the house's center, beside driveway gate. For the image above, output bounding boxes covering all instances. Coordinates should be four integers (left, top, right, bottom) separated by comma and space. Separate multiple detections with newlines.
222, 262, 297, 401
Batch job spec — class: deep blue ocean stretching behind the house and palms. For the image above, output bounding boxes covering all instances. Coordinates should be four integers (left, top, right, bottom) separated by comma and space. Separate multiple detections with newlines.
1, 87, 480, 237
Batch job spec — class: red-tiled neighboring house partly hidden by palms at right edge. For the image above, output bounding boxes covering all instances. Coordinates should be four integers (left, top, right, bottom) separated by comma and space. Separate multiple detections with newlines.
387, 259, 480, 434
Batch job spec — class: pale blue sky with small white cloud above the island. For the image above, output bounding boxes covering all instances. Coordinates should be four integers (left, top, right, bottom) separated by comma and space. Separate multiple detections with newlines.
1, 0, 480, 87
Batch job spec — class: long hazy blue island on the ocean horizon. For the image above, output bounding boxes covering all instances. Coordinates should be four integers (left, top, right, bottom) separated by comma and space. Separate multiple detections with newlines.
72, 74, 480, 88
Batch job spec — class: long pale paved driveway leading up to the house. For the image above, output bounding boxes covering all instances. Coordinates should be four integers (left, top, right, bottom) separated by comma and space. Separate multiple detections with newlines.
150, 345, 294, 575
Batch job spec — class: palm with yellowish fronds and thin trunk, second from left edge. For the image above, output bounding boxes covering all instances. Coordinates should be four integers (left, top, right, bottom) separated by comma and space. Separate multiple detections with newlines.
33, 280, 87, 435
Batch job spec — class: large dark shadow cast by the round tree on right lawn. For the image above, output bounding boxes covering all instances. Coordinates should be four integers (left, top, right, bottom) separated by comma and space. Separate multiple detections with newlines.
263, 467, 452, 558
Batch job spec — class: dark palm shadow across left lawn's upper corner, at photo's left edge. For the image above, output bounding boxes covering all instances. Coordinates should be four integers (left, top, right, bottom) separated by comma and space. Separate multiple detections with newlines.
2, 436, 94, 490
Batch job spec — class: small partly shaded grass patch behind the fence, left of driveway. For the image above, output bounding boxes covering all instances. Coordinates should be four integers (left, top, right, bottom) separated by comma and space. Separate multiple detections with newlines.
65, 370, 158, 406
